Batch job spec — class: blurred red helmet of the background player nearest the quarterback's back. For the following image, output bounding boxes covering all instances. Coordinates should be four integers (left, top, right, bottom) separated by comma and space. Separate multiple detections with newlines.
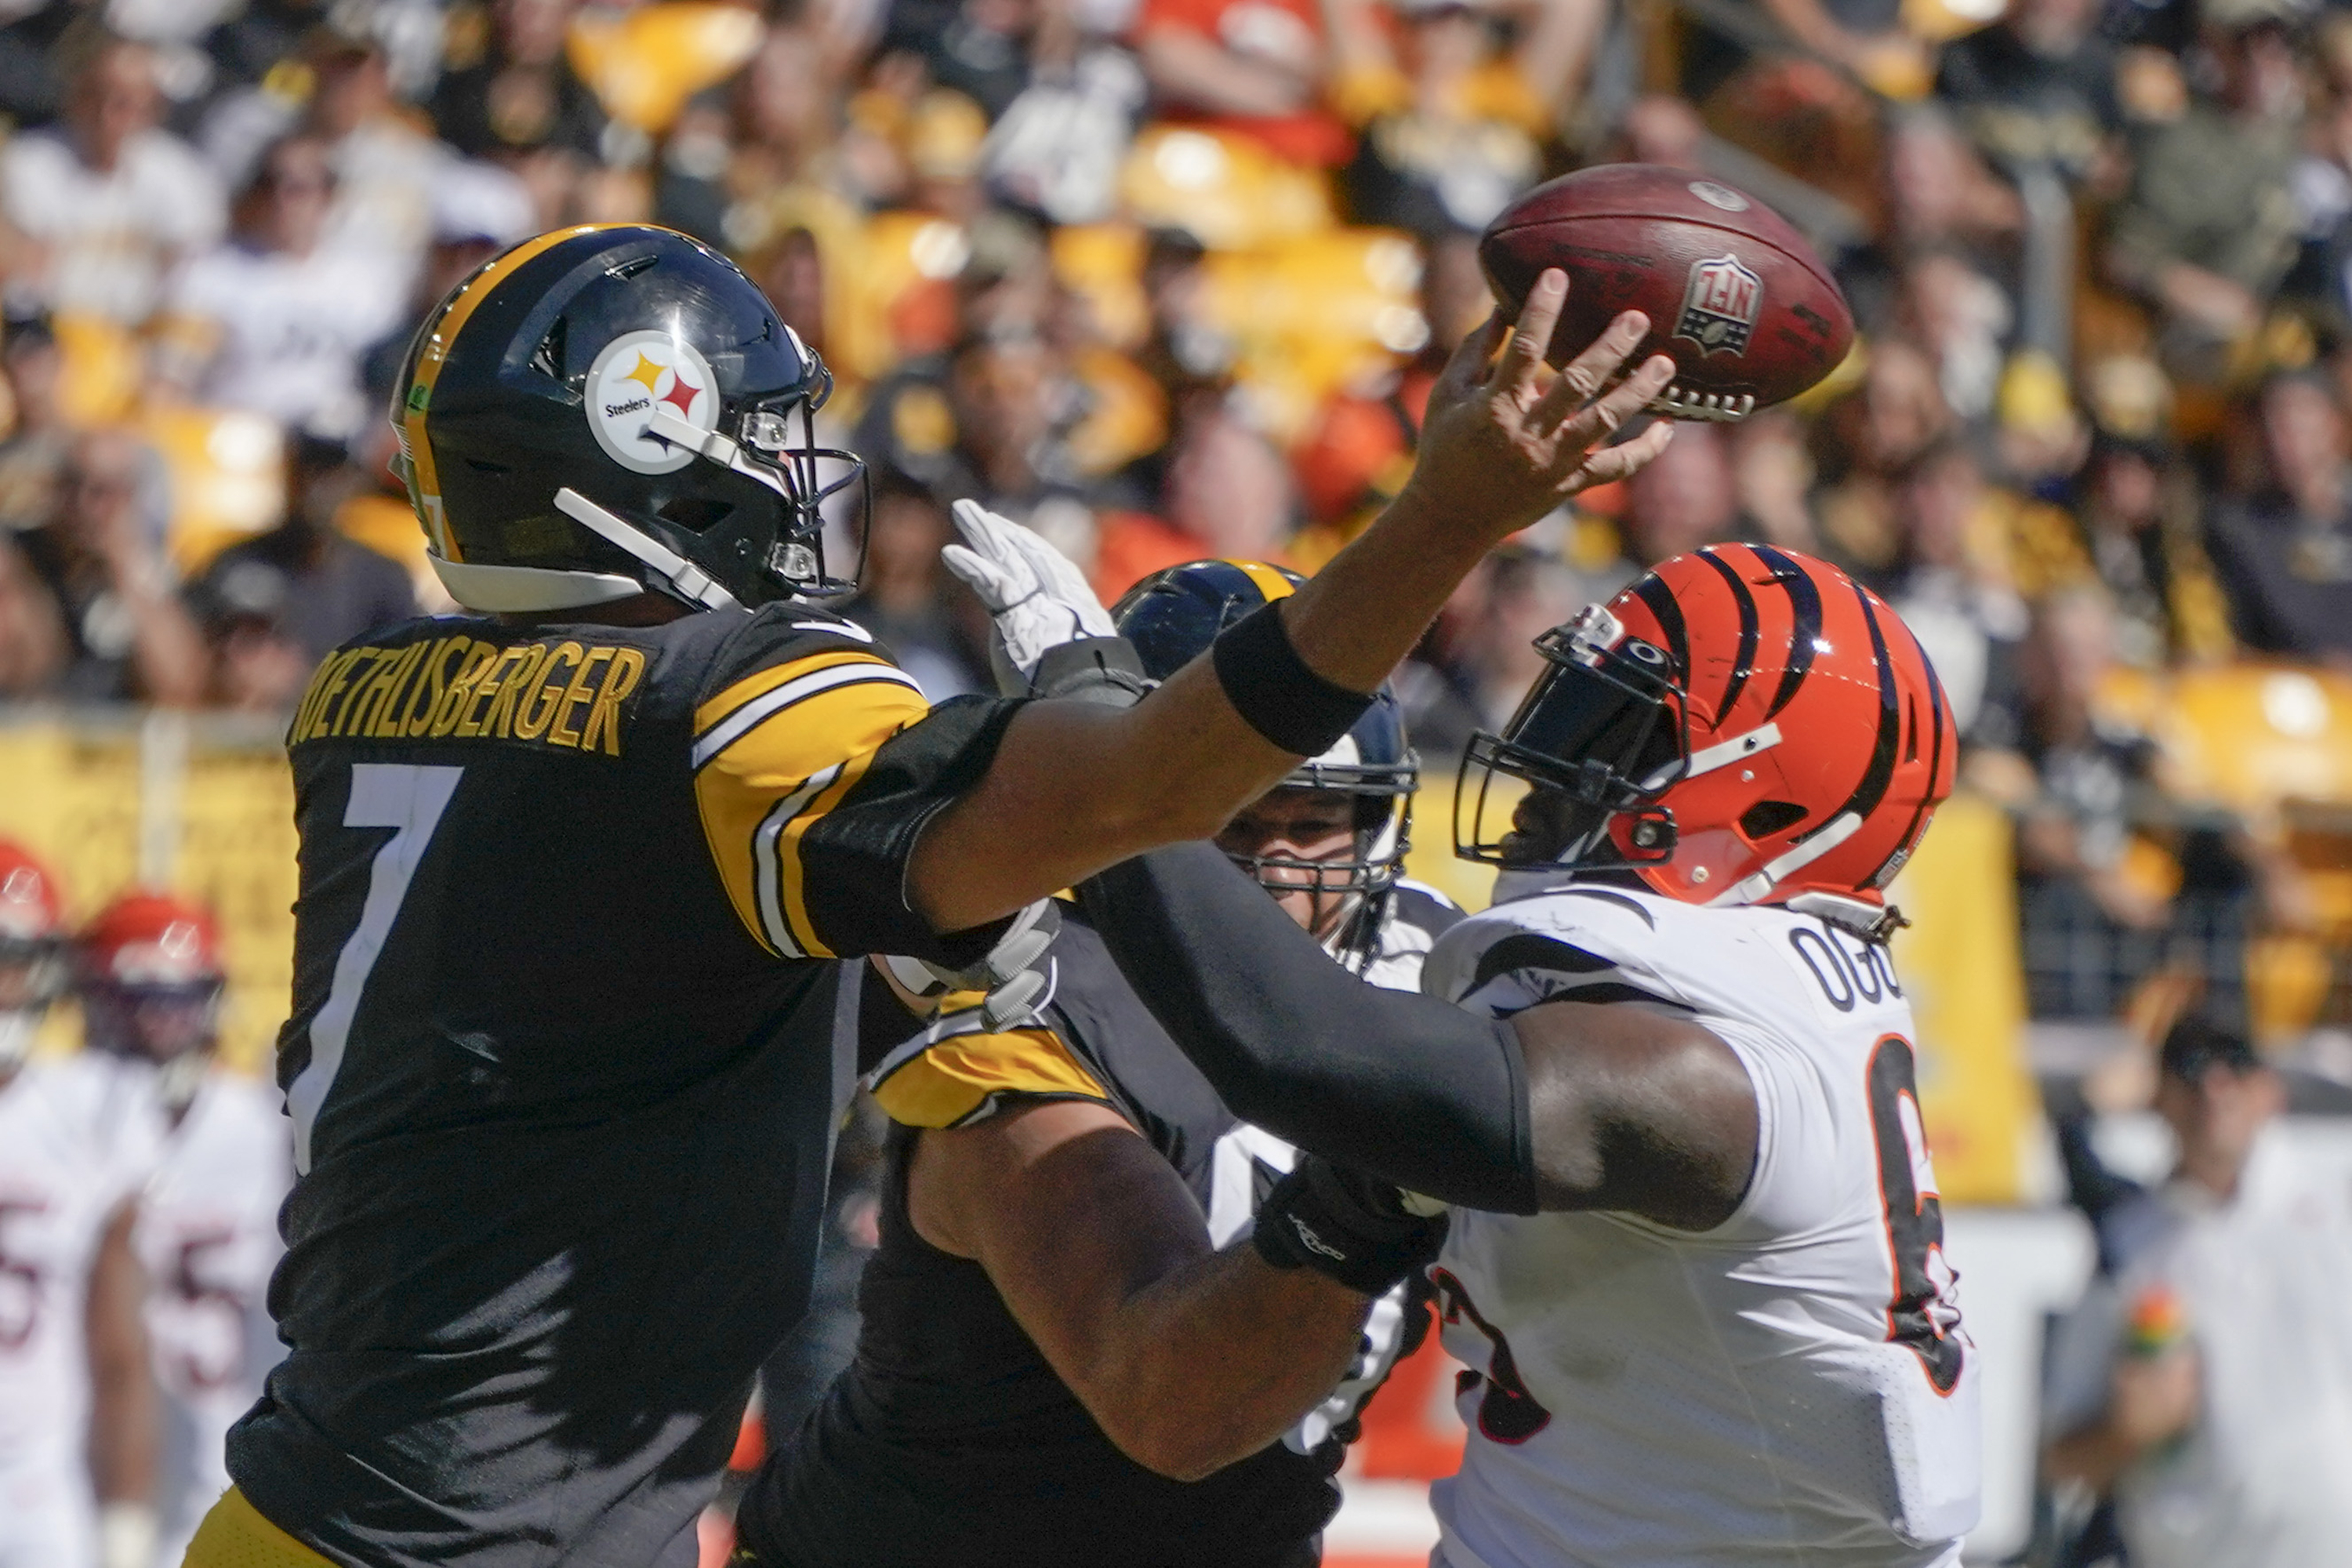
75, 893, 228, 1105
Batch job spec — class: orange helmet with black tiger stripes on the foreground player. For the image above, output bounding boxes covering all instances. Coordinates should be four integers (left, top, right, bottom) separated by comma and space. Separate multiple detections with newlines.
1456, 546, 1959, 914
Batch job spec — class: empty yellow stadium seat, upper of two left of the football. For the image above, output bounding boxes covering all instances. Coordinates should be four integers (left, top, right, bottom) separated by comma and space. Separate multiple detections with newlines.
1120, 125, 1334, 249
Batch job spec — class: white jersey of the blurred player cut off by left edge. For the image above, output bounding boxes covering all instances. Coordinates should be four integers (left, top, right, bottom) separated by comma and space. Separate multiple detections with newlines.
0, 1055, 158, 1568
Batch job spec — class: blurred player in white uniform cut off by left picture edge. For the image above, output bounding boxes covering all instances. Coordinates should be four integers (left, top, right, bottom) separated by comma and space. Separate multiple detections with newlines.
0, 844, 160, 1568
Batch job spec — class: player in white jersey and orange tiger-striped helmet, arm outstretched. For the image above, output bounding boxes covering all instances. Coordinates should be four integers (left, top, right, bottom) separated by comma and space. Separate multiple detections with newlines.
974, 546, 1978, 1568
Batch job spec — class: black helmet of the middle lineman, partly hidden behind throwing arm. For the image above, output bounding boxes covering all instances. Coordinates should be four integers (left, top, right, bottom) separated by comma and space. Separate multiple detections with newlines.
1110, 562, 1421, 968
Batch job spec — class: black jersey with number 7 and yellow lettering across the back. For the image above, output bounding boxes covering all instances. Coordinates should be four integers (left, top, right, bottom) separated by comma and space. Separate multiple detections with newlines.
228, 604, 1011, 1568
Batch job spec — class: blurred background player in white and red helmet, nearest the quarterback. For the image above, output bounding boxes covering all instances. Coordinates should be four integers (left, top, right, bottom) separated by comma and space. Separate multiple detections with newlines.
75, 893, 294, 1568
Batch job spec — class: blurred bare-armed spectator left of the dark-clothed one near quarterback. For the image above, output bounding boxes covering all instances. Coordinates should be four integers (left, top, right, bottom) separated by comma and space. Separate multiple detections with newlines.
19, 430, 207, 708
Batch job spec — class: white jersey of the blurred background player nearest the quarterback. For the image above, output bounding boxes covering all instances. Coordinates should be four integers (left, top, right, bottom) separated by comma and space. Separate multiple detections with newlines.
132, 1072, 294, 1566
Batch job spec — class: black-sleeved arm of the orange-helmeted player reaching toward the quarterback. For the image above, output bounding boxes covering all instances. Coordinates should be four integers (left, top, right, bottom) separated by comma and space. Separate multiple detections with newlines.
1080, 844, 1757, 1229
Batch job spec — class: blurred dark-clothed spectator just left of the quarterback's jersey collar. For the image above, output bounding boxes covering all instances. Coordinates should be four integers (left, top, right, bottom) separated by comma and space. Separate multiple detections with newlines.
188, 437, 416, 713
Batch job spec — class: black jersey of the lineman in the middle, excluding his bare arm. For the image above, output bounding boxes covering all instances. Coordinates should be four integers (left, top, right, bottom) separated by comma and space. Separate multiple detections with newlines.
736, 888, 1461, 1568
